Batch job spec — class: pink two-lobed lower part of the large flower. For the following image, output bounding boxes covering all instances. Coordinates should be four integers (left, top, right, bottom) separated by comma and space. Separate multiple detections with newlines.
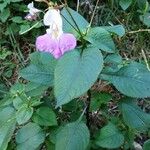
36, 33, 77, 59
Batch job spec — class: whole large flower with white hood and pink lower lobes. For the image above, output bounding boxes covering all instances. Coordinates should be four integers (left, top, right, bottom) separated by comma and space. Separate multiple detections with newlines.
36, 8, 77, 58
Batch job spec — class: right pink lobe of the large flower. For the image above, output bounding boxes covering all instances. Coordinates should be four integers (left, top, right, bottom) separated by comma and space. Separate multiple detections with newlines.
59, 33, 77, 54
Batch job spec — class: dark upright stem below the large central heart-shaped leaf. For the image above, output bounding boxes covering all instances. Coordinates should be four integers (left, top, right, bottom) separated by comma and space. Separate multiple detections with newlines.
86, 90, 91, 129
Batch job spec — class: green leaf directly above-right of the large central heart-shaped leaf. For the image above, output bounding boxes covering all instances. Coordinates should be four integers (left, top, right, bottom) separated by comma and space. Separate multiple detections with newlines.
85, 27, 115, 53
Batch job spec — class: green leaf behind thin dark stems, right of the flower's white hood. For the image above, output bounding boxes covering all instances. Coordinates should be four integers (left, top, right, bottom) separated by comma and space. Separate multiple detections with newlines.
61, 7, 89, 33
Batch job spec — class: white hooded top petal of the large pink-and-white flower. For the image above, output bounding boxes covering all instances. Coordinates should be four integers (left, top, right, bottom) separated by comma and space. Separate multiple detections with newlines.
44, 9, 62, 28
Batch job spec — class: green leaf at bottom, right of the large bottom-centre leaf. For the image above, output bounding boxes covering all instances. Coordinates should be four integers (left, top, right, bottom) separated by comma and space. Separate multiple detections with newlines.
96, 123, 124, 149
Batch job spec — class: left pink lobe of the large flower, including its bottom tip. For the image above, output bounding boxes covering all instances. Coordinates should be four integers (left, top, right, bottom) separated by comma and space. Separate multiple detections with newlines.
36, 34, 62, 58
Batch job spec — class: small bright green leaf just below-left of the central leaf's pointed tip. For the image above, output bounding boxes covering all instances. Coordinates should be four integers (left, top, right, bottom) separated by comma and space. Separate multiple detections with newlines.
33, 107, 57, 126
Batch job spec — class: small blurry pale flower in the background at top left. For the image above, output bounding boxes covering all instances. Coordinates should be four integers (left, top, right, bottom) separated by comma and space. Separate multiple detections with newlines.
25, 2, 41, 21
